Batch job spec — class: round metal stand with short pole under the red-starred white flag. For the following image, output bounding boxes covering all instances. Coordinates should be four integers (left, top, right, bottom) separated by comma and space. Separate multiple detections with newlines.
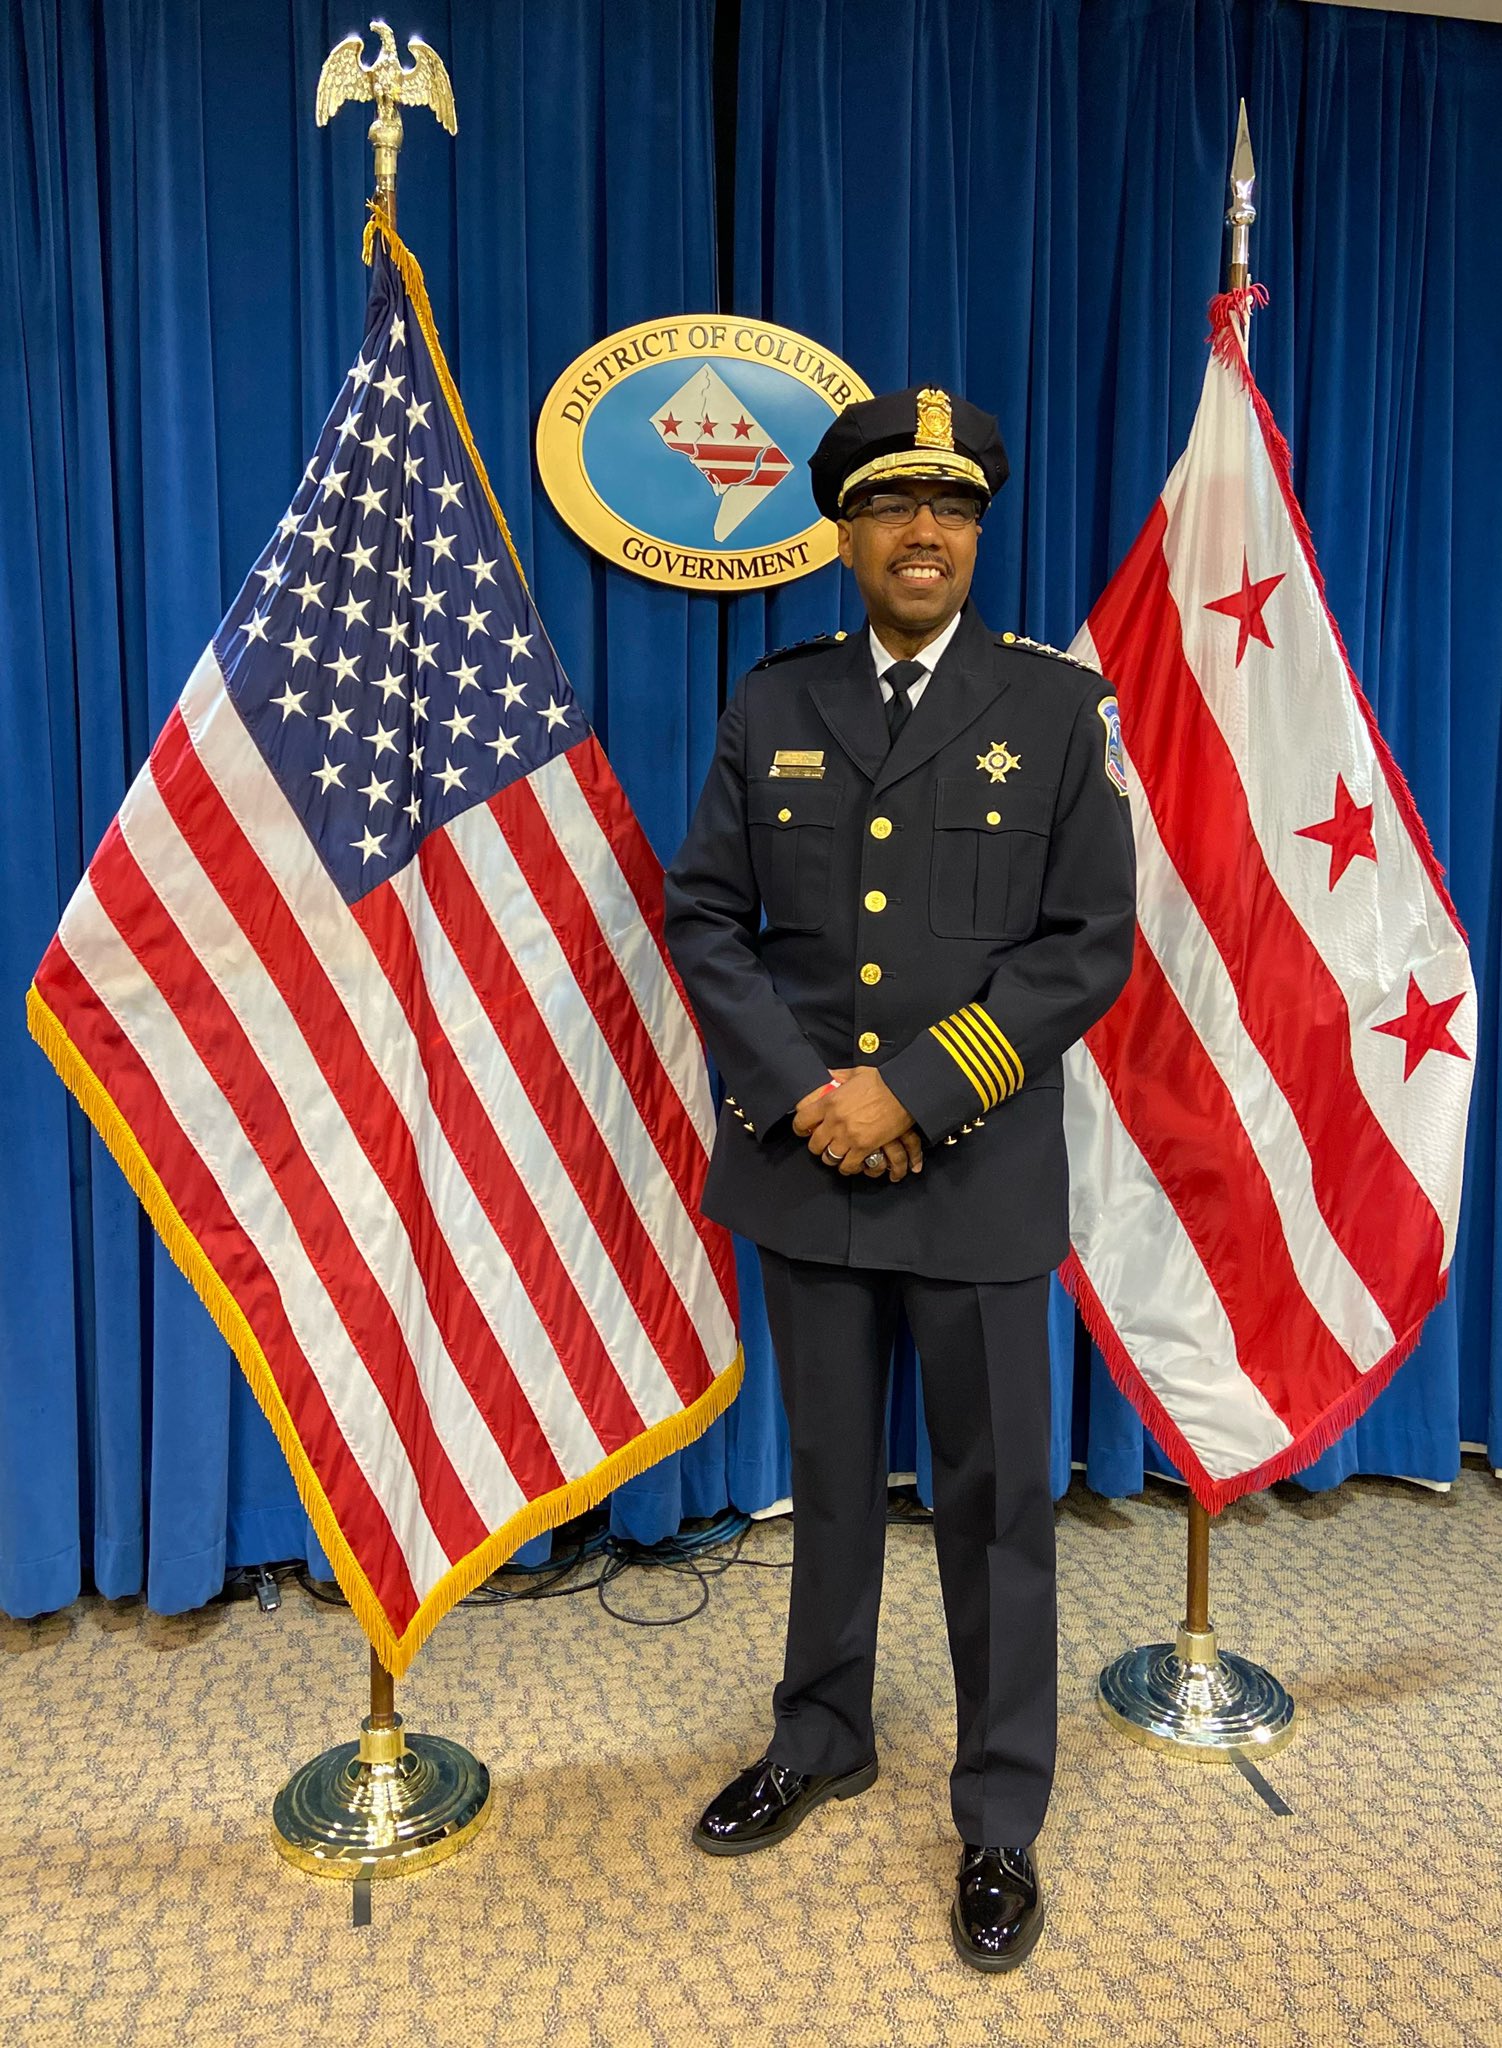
1096, 1499, 1293, 1761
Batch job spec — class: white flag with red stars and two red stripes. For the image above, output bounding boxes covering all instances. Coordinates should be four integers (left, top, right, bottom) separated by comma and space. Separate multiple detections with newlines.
1063, 287, 1475, 1513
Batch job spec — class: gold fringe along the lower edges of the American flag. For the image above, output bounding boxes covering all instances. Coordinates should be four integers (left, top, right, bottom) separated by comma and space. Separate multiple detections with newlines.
27, 987, 746, 1677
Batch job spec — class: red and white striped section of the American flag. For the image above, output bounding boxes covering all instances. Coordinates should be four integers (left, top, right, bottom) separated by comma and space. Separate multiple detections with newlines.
37, 649, 738, 1640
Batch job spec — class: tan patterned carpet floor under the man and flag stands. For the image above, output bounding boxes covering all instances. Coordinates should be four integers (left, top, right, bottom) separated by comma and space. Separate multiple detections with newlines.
0, 1466, 1502, 2048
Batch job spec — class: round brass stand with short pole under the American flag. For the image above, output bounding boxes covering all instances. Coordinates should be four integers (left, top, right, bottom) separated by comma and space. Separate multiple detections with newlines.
273, 1651, 490, 1878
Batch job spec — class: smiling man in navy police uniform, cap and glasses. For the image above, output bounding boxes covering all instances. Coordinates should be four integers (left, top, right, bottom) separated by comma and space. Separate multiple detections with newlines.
666, 389, 1135, 1970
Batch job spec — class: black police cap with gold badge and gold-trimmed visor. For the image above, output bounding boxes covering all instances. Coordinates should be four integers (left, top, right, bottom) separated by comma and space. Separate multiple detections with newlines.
809, 385, 1010, 518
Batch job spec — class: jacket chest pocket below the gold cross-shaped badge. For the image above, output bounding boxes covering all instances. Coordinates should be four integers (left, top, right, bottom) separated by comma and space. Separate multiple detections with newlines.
928, 776, 1053, 940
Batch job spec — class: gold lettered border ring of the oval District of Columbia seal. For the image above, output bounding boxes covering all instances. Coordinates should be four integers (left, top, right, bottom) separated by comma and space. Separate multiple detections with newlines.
537, 313, 871, 596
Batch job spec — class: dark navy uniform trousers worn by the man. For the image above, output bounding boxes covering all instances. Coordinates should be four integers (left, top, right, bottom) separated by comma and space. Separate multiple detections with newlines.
760, 1251, 1055, 1845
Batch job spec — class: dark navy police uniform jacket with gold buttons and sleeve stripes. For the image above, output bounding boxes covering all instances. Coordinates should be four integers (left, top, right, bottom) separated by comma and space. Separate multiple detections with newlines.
666, 606, 1135, 1280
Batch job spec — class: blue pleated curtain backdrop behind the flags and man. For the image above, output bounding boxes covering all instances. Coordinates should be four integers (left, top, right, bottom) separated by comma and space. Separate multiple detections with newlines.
0, 0, 1502, 1614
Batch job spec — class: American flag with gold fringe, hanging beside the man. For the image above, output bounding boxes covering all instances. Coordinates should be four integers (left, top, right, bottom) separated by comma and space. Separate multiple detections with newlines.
31, 223, 740, 1673
